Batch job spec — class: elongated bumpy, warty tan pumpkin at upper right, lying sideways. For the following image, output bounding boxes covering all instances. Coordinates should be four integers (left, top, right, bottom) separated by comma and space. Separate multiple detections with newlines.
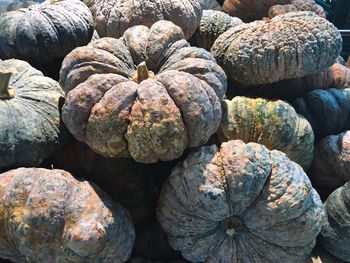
211, 12, 342, 87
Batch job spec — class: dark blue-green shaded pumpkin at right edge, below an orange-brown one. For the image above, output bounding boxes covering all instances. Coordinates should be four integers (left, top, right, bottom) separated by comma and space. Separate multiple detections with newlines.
292, 88, 350, 141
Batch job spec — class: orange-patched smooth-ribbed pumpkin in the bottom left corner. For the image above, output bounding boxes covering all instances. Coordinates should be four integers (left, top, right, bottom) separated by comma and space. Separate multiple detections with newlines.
0, 168, 135, 263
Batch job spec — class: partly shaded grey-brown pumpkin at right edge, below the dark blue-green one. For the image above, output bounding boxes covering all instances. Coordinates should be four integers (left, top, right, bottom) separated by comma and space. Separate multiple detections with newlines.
309, 131, 350, 196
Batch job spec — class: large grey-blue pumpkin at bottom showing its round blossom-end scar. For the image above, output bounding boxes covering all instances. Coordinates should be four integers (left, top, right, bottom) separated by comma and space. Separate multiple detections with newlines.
157, 140, 324, 263
